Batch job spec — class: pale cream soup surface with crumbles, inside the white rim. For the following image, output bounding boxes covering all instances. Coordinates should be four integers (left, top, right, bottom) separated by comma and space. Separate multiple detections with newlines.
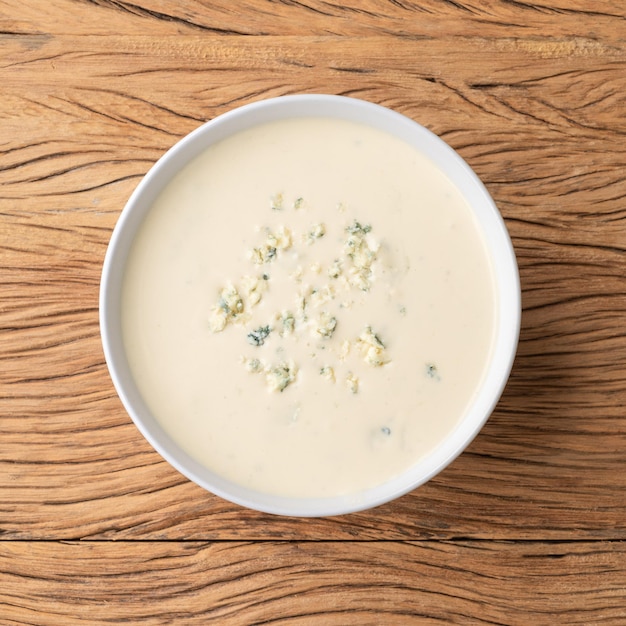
122, 118, 496, 497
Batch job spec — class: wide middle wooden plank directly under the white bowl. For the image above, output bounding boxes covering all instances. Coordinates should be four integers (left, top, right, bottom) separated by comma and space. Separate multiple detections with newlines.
0, 29, 626, 539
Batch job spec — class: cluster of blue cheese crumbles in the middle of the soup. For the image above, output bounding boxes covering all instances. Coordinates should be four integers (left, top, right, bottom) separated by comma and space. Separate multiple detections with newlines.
209, 193, 391, 394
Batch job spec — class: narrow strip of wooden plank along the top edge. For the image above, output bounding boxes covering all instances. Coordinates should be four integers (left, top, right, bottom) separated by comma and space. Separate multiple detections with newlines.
0, 0, 626, 45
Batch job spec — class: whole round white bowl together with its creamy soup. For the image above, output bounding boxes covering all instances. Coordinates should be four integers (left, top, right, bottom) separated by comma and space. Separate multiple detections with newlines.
100, 95, 520, 516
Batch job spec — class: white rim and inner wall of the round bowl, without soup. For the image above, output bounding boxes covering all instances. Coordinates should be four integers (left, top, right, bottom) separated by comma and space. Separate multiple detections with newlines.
100, 95, 521, 516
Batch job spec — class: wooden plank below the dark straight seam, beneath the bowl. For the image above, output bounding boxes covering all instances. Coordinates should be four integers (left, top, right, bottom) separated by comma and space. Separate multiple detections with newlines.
0, 542, 626, 626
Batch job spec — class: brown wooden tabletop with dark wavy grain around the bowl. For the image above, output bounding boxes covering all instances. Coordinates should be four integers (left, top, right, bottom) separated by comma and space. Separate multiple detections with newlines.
0, 0, 626, 625
